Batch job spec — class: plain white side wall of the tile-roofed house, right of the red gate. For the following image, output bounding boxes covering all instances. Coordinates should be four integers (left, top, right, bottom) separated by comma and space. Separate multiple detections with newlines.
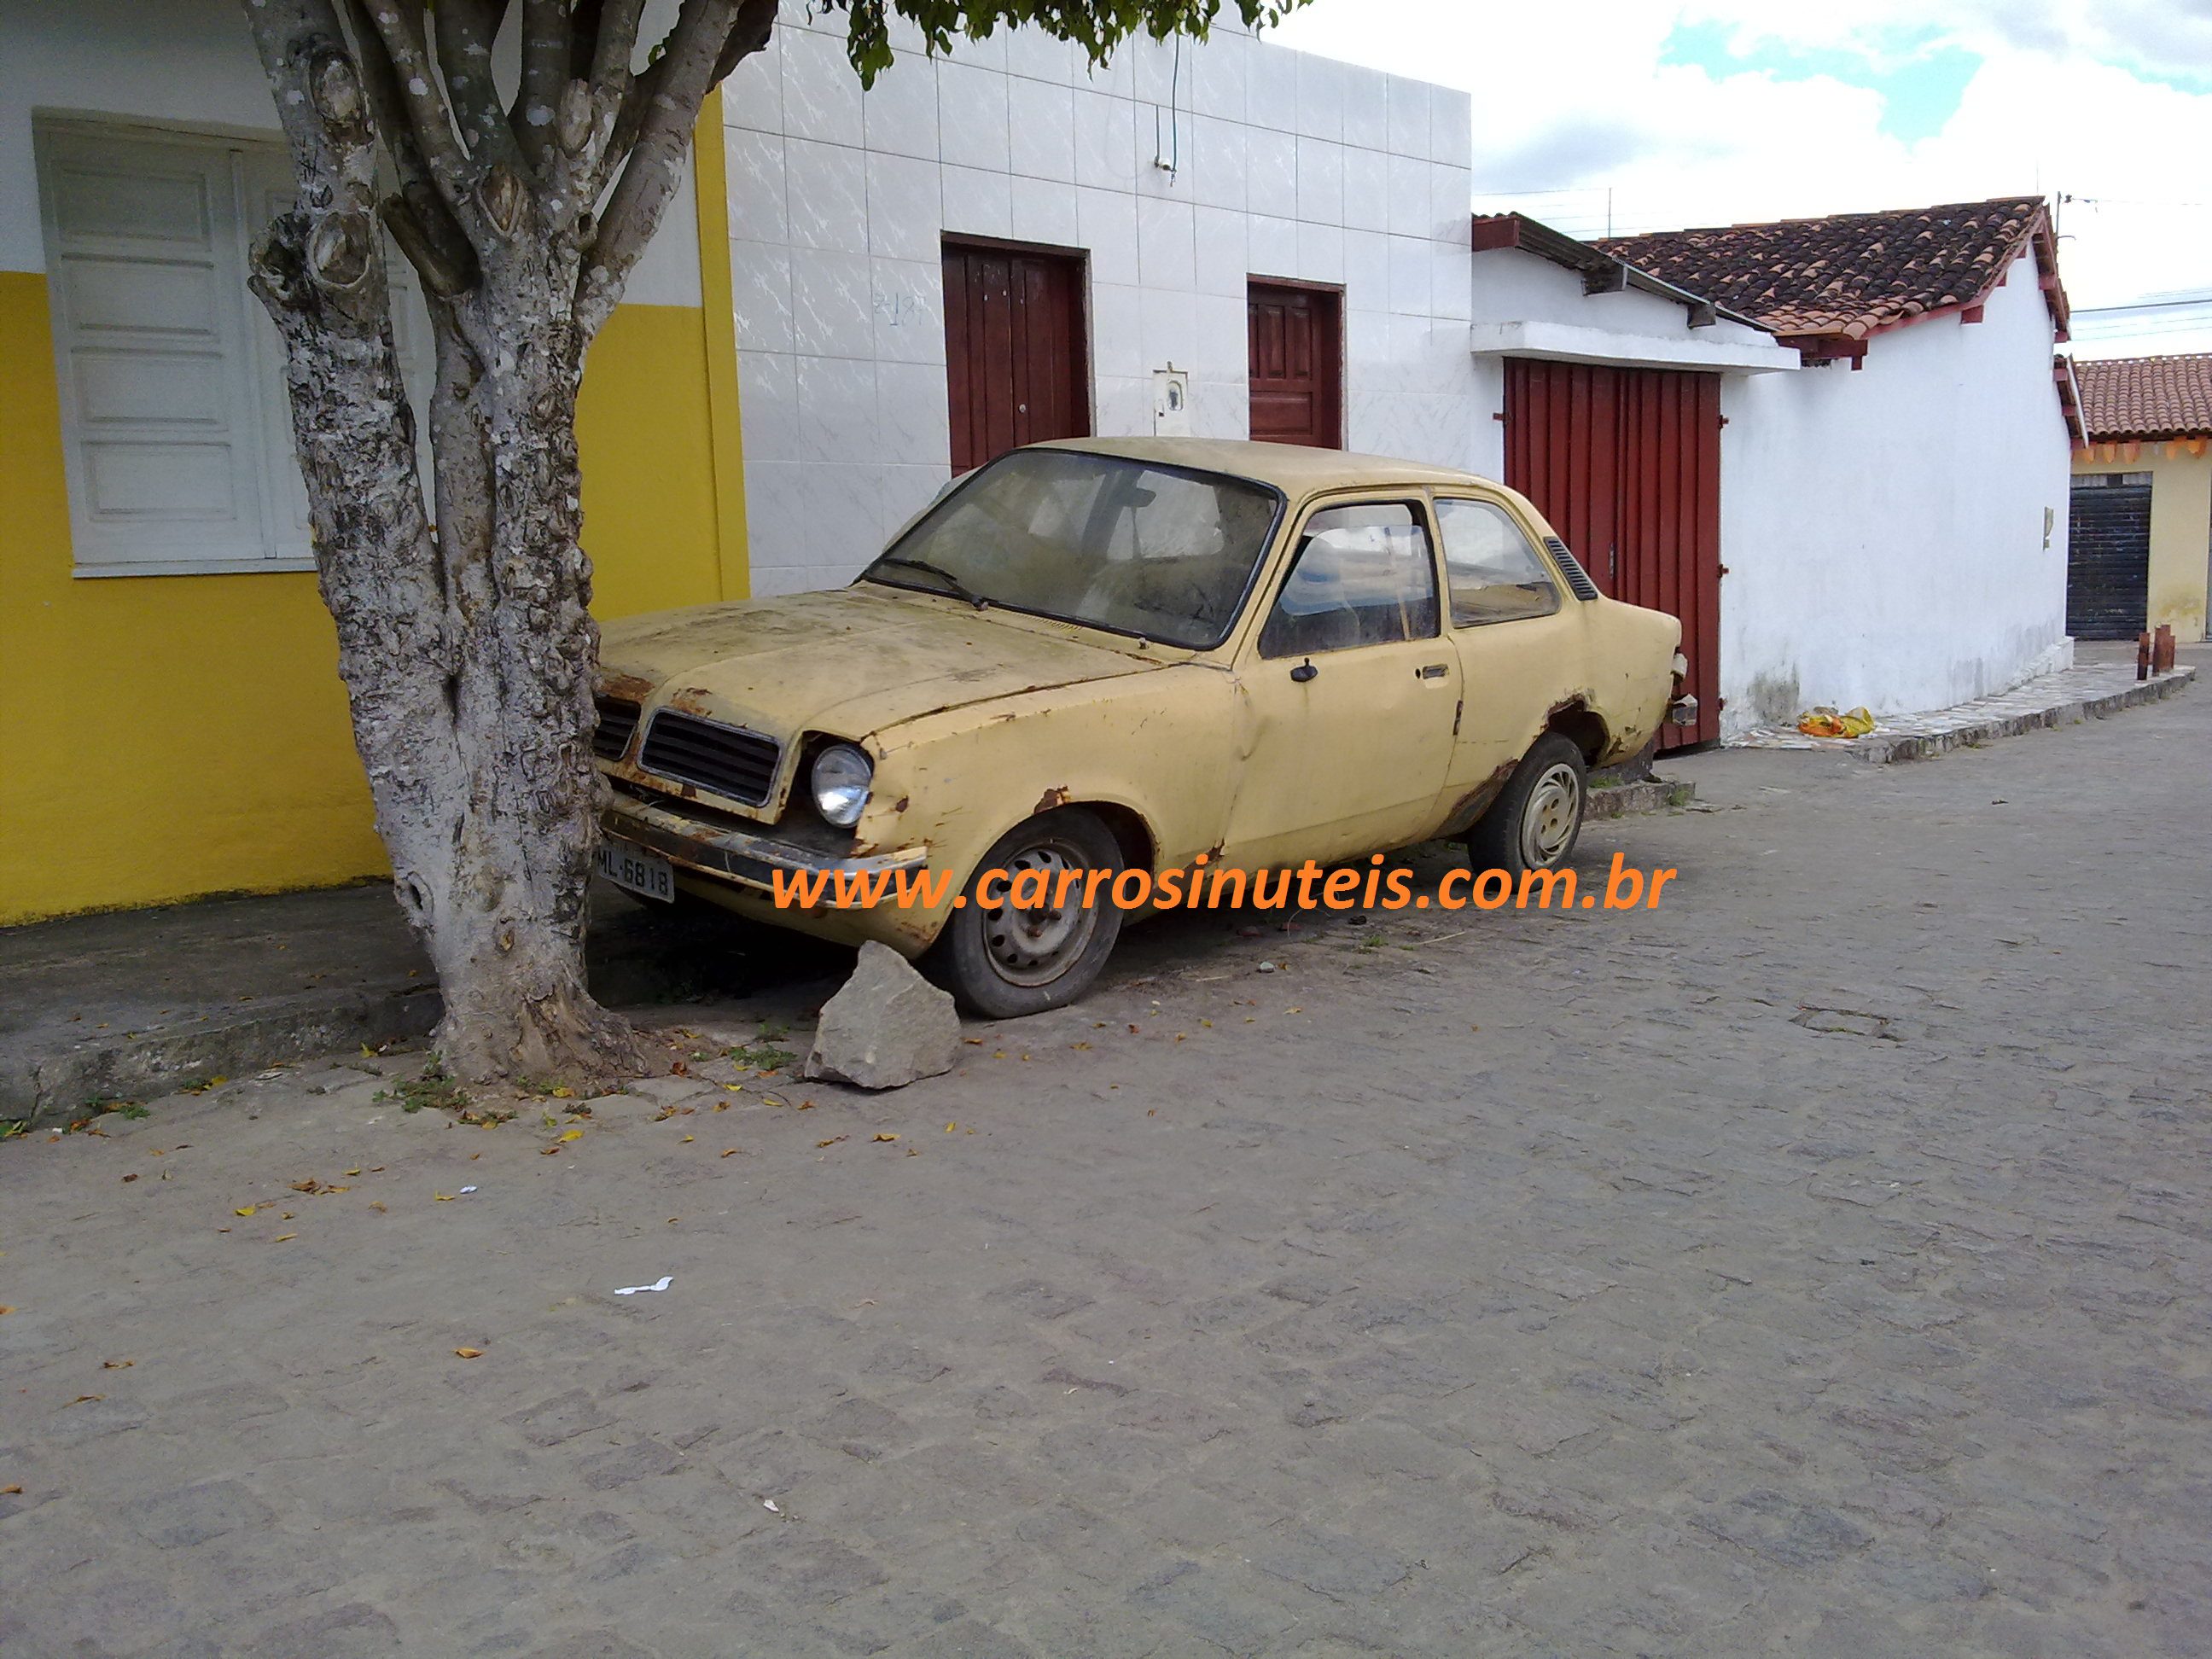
1721, 257, 2073, 735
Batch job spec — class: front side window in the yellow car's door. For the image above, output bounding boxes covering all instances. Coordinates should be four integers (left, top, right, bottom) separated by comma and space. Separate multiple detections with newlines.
1259, 502, 1438, 657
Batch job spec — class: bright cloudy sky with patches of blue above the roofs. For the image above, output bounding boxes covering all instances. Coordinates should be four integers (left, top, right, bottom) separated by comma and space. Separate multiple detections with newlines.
1274, 0, 2212, 354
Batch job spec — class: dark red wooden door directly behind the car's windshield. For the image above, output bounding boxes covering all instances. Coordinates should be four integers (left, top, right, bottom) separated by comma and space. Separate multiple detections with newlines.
945, 242, 1091, 474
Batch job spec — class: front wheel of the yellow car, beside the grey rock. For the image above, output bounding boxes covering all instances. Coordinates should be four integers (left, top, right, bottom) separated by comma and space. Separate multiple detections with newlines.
929, 807, 1126, 1020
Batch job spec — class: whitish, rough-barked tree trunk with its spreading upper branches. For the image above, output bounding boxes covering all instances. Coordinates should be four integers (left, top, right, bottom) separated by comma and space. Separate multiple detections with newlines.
243, 0, 777, 1086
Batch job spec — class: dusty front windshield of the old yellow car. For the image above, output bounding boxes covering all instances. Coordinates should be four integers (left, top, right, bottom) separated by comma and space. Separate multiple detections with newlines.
863, 449, 1283, 650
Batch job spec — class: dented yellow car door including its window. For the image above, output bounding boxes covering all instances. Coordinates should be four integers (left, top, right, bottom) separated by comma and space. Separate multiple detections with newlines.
1223, 493, 1460, 867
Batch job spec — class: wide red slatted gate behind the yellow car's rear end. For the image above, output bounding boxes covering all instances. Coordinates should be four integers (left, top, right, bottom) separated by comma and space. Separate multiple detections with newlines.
1506, 358, 1721, 750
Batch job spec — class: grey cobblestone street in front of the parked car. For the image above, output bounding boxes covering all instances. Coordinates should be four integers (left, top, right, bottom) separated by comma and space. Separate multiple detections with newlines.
0, 688, 2212, 1659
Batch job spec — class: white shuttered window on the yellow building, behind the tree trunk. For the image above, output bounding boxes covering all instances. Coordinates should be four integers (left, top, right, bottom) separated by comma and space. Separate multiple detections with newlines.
35, 119, 429, 575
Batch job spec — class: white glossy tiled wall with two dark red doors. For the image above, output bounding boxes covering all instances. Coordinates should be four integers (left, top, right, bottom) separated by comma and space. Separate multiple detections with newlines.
724, 14, 1491, 595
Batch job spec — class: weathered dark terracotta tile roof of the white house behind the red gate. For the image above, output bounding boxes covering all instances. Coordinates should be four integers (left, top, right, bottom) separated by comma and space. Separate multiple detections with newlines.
1597, 197, 2066, 339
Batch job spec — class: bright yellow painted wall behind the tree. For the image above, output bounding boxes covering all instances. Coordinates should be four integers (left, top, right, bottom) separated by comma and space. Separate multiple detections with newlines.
0, 285, 743, 924
